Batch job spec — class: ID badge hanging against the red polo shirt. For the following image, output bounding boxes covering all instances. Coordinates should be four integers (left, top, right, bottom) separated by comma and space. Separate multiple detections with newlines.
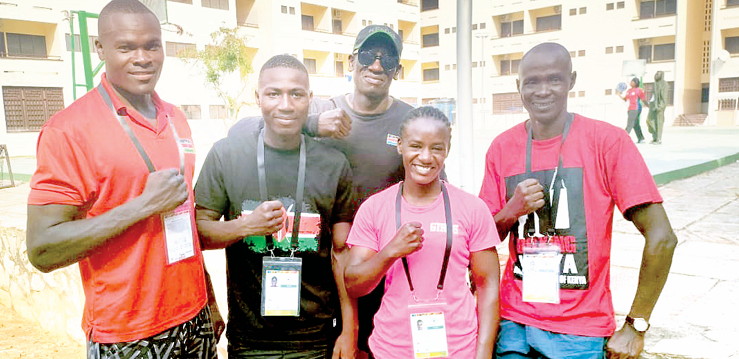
161, 199, 195, 264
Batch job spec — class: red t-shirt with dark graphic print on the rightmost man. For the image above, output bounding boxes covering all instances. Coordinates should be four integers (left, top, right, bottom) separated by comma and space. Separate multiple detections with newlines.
480, 115, 662, 337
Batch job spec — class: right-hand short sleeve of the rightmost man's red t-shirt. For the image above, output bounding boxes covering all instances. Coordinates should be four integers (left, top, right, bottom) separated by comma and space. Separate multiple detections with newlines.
604, 131, 662, 217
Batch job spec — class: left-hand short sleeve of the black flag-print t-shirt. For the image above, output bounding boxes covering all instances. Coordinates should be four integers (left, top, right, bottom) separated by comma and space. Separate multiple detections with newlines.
195, 143, 228, 214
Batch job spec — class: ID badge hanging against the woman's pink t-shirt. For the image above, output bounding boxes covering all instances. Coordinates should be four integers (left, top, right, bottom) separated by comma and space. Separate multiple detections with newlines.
410, 311, 449, 359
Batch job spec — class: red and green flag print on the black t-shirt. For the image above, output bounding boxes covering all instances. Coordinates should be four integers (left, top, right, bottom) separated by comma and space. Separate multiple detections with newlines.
241, 197, 321, 253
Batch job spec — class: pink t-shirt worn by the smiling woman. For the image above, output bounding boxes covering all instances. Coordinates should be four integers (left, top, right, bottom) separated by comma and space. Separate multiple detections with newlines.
347, 183, 500, 359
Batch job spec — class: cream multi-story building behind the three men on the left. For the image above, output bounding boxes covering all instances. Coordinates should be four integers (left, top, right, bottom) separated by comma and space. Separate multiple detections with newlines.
0, 0, 422, 158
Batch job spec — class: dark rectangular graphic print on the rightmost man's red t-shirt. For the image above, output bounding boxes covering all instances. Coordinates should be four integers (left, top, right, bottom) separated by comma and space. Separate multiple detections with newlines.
506, 168, 589, 289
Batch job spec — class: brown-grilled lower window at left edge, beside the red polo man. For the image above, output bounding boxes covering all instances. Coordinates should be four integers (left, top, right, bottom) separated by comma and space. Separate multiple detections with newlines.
3, 86, 64, 132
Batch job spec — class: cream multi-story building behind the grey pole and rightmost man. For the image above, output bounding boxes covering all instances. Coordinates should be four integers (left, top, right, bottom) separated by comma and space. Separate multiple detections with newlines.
421, 0, 739, 126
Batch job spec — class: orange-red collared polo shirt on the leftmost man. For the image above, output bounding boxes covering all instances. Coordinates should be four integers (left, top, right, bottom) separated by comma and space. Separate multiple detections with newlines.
28, 75, 207, 343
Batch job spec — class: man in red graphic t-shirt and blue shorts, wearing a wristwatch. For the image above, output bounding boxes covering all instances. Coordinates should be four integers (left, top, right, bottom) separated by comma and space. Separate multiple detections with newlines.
480, 43, 677, 358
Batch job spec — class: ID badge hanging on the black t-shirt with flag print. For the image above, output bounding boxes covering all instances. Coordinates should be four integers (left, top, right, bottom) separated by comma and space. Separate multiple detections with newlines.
262, 257, 303, 317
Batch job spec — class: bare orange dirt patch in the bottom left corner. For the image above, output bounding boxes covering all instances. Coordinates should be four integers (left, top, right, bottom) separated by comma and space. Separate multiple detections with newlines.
0, 305, 85, 359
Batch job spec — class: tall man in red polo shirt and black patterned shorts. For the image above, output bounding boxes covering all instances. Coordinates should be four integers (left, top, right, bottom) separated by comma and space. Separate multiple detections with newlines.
27, 0, 220, 358
